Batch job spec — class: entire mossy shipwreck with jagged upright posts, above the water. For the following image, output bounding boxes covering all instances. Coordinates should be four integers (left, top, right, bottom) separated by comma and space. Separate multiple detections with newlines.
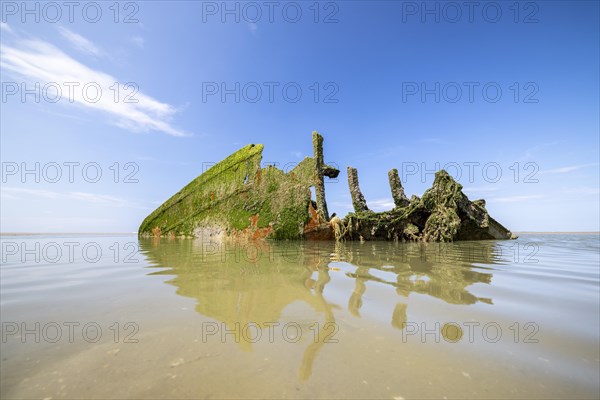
139, 132, 516, 242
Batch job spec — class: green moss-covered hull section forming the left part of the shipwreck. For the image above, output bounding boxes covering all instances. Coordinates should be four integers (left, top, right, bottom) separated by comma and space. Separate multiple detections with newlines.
139, 132, 340, 239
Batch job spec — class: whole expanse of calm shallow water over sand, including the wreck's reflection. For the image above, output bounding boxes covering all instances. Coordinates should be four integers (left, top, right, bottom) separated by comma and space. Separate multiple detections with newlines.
0, 234, 600, 399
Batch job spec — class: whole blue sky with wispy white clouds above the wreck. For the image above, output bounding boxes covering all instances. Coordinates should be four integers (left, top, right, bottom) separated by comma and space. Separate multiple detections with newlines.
0, 1, 600, 232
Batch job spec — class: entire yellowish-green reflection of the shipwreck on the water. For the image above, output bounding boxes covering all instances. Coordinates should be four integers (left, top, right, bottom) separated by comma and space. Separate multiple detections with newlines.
140, 238, 502, 379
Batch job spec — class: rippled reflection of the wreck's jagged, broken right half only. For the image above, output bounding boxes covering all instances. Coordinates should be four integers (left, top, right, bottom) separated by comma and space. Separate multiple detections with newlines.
336, 241, 502, 308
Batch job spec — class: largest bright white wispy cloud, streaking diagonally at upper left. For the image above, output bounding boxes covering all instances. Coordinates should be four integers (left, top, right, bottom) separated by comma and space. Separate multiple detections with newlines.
0, 28, 188, 136
